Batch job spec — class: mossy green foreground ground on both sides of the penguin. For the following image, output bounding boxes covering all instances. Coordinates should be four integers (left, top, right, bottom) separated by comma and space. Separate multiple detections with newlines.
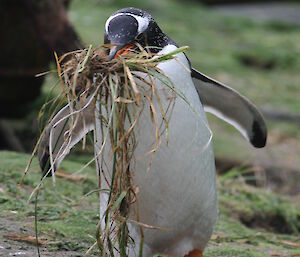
0, 152, 300, 256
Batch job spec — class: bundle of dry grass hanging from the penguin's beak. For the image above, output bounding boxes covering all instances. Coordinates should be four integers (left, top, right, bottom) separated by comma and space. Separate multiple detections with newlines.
23, 45, 187, 256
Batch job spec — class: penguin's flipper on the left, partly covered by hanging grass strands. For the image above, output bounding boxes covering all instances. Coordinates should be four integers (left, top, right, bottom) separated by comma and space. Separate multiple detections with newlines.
37, 98, 95, 176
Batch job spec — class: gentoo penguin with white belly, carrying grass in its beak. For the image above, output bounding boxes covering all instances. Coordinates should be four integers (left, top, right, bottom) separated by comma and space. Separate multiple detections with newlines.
38, 8, 267, 257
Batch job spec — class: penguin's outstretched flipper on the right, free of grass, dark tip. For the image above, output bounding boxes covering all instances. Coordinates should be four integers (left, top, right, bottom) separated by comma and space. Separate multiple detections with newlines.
191, 69, 267, 148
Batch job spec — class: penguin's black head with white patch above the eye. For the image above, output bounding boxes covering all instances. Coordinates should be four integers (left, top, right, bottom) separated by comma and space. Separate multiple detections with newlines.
104, 7, 173, 59
